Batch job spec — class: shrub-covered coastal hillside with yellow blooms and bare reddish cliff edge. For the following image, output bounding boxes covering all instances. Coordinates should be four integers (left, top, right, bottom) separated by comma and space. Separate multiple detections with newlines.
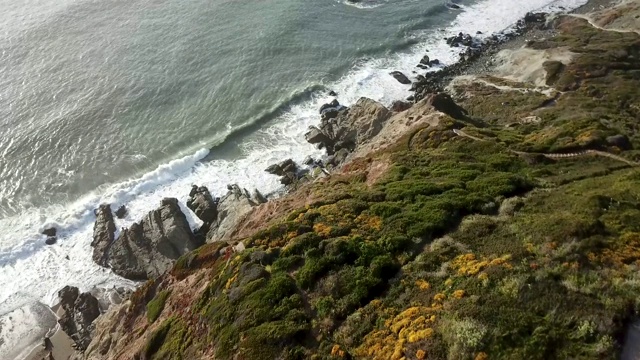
84, 3, 640, 359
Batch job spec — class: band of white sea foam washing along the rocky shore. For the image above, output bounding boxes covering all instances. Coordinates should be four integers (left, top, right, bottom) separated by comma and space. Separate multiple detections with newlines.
0, 0, 586, 354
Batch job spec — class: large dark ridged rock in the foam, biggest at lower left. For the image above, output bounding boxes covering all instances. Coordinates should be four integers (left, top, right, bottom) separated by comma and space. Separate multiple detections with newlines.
108, 198, 201, 280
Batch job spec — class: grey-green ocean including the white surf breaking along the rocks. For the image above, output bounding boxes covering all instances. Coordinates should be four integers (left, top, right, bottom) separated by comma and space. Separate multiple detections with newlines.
0, 0, 586, 359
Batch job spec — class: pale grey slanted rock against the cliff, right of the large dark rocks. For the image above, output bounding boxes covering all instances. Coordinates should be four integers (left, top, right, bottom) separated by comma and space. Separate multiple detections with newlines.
207, 184, 258, 243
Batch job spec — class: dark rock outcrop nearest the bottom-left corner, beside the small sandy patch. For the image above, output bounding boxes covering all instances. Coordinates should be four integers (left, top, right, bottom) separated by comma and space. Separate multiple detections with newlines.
58, 286, 100, 350
